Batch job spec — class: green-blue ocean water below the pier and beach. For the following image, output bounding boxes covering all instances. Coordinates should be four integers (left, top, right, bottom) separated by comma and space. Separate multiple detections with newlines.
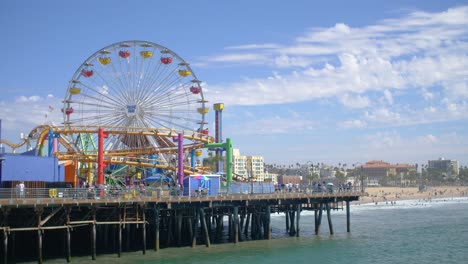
41, 198, 468, 264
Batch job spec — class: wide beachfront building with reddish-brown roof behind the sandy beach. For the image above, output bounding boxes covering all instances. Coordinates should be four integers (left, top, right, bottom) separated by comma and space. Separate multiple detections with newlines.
360, 160, 416, 186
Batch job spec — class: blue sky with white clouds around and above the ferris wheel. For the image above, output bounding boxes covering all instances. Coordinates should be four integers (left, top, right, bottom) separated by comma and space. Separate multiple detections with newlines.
0, 0, 468, 165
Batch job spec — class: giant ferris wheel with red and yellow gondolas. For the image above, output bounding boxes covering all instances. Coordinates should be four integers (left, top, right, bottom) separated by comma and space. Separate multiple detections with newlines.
62, 40, 208, 154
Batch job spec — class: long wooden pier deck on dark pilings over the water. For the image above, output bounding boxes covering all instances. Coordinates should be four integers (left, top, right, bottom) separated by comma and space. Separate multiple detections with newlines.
0, 192, 366, 263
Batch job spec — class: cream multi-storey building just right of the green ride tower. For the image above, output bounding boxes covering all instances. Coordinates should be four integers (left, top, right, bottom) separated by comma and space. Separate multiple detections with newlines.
232, 149, 265, 181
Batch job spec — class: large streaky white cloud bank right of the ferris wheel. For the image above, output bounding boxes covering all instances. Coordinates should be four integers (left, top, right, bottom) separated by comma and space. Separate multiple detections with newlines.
202, 4, 468, 116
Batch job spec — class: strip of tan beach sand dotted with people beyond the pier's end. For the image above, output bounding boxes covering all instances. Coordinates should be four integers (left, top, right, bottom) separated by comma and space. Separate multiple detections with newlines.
356, 186, 468, 204
